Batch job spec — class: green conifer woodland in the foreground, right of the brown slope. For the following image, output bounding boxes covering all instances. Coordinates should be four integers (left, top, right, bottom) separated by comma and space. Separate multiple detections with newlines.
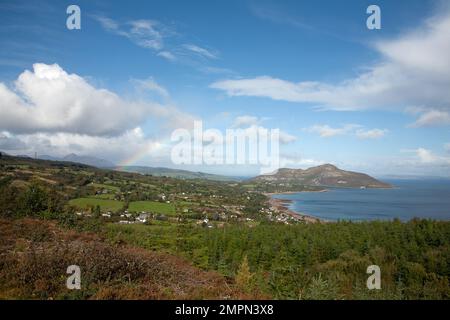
108, 220, 450, 299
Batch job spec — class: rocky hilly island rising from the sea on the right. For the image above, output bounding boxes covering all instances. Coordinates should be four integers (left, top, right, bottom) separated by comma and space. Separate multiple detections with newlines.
250, 164, 392, 188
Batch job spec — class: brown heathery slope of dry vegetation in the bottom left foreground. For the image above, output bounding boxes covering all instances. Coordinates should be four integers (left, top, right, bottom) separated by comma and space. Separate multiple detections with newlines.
0, 219, 242, 299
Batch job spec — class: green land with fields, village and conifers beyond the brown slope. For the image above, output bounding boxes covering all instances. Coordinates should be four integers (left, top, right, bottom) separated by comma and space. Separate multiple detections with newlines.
0, 157, 450, 299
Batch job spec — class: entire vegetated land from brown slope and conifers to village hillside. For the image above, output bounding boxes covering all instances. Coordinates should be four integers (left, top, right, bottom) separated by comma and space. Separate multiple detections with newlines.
0, 155, 450, 299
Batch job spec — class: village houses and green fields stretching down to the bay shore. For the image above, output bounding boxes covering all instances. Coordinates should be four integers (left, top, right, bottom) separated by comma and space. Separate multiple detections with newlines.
68, 182, 317, 228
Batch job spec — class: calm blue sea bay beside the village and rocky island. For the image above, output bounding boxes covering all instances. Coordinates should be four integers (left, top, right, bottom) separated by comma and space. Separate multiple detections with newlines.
273, 179, 450, 221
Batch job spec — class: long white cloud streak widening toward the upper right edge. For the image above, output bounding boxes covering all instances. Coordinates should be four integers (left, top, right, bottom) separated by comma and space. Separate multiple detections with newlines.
210, 10, 450, 124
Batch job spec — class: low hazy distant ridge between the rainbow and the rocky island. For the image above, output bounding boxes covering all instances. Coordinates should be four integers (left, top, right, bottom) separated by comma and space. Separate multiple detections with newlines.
114, 166, 242, 181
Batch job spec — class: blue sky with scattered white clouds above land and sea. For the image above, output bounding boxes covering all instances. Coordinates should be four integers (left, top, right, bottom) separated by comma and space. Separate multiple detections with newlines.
0, 0, 450, 176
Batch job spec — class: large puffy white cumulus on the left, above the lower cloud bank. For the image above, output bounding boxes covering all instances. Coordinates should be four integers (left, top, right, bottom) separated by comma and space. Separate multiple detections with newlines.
0, 63, 192, 136
